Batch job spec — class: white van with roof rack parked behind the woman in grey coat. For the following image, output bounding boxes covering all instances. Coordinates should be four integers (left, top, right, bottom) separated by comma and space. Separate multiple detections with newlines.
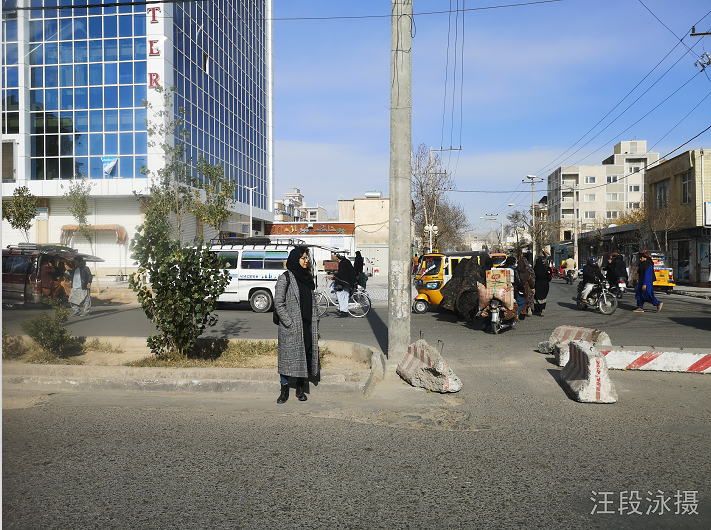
210, 237, 316, 313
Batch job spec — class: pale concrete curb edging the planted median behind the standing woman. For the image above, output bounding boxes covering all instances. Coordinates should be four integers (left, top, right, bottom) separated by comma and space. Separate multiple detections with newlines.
2, 337, 385, 396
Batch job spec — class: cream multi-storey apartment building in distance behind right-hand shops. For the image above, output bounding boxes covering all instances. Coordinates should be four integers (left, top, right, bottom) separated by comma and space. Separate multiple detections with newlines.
547, 140, 659, 240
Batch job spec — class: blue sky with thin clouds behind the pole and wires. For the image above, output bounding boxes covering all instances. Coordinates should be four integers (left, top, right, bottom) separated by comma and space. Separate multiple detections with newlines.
274, 0, 711, 229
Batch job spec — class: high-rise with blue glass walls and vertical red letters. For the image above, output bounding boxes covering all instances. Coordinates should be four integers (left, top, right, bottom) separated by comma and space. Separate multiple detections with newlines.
2, 0, 273, 268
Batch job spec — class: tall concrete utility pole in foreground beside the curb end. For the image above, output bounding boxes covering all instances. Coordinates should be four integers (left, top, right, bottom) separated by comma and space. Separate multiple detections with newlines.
388, 0, 413, 358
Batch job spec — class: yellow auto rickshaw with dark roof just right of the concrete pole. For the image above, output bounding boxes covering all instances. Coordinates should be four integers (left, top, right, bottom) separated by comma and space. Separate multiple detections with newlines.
412, 252, 486, 314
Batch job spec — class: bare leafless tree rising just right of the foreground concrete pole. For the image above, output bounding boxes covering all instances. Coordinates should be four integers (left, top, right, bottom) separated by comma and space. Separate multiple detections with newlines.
412, 144, 469, 251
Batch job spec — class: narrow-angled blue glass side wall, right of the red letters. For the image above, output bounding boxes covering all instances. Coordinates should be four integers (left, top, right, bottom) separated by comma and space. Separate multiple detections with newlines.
173, 0, 268, 209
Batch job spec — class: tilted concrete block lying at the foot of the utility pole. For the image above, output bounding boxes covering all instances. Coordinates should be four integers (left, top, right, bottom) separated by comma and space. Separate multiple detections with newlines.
396, 339, 462, 392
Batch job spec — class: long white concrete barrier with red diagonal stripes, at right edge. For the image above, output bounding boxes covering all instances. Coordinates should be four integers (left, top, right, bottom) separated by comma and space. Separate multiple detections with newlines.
600, 346, 711, 374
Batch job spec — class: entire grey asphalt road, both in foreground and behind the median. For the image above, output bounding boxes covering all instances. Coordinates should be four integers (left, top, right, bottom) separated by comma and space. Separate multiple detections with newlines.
2, 283, 711, 529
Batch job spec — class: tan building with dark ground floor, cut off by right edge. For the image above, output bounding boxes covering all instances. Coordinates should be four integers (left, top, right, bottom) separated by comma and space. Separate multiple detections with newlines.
645, 149, 711, 283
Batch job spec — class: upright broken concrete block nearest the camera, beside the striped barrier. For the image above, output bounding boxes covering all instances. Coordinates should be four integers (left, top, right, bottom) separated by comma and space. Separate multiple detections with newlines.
560, 341, 617, 403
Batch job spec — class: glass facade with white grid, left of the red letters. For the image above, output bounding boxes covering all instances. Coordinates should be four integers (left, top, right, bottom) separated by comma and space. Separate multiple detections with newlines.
23, 0, 147, 180
